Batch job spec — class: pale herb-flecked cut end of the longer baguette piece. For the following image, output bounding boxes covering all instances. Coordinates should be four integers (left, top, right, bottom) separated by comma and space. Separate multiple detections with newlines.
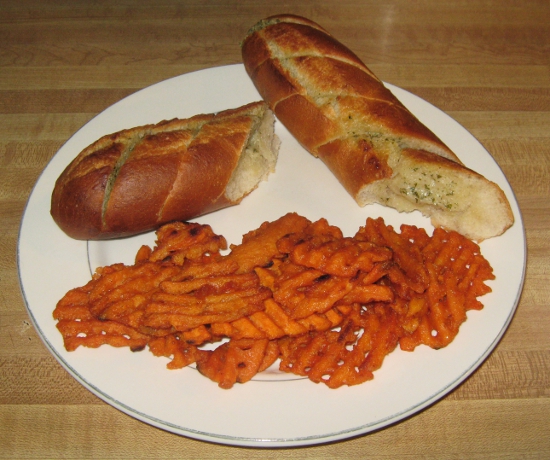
355, 149, 514, 242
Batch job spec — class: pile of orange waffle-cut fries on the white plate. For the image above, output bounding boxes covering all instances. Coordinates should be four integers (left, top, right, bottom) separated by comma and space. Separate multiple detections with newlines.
53, 213, 494, 389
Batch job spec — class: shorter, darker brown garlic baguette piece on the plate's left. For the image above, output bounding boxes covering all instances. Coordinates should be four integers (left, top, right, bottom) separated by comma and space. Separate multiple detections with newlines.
51, 101, 279, 239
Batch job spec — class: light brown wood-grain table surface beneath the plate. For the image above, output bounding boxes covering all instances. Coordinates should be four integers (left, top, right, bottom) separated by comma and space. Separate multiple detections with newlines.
0, 0, 550, 459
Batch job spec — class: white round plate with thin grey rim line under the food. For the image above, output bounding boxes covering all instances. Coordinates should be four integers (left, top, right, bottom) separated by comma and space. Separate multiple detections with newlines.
18, 65, 526, 447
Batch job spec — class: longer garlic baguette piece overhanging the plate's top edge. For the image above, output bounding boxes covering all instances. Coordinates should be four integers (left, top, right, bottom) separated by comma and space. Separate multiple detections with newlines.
242, 15, 514, 241
